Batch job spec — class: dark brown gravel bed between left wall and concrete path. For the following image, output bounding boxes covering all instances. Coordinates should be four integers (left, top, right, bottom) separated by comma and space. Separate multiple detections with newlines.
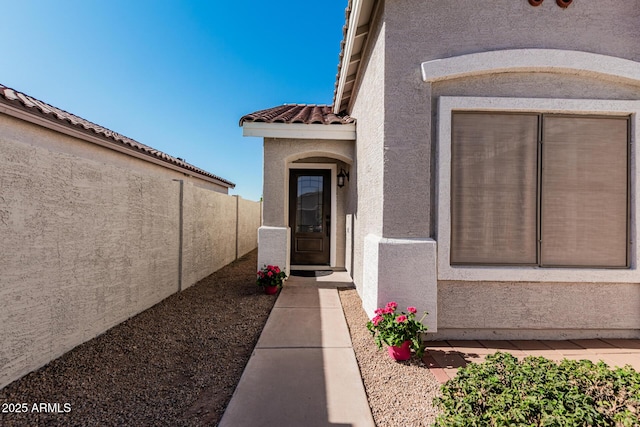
0, 251, 276, 427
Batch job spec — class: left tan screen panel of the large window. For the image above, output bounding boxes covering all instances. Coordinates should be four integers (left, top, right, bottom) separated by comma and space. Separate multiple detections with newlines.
451, 113, 538, 264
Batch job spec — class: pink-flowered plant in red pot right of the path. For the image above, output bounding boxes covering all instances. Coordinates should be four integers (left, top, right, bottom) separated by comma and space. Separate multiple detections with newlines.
367, 301, 427, 360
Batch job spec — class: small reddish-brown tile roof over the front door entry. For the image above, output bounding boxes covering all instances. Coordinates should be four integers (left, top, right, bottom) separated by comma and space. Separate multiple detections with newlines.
240, 104, 355, 126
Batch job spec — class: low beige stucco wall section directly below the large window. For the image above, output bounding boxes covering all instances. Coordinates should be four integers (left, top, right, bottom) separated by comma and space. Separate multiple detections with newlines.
434, 281, 640, 339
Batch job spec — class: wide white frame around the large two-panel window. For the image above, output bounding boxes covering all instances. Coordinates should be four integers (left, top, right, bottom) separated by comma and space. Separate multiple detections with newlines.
436, 96, 640, 283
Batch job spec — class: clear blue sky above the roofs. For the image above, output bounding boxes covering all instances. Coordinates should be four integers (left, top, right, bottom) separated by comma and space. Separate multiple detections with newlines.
0, 0, 347, 200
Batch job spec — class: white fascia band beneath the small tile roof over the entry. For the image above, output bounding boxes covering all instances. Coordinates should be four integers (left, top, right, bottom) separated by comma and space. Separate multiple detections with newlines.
242, 122, 356, 141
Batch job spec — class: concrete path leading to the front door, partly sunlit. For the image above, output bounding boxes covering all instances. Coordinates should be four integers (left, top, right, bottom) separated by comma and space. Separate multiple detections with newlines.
219, 272, 375, 427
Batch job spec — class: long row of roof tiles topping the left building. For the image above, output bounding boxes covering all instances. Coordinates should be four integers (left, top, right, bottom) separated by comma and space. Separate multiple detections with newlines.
0, 84, 235, 188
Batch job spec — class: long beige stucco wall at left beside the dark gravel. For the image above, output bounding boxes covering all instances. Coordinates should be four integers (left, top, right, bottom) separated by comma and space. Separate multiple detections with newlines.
0, 115, 259, 387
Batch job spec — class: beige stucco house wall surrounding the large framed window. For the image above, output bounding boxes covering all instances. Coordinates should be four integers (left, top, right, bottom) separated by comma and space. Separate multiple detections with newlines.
349, 0, 640, 338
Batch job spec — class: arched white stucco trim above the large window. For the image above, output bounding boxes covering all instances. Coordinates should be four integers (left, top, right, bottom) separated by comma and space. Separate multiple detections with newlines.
421, 49, 640, 84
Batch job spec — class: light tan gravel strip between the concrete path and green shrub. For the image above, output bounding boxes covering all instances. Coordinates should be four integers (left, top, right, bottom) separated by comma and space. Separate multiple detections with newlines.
340, 289, 440, 427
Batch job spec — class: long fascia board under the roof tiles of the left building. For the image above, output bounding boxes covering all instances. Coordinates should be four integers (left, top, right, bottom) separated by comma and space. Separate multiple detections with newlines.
0, 103, 235, 188
